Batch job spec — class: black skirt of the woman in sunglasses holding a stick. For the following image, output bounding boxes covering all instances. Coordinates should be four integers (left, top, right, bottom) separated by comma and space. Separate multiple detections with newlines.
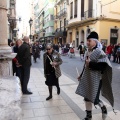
45, 72, 58, 86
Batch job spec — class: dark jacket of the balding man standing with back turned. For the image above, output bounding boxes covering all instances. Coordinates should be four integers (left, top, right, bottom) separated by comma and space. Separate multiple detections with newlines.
16, 42, 31, 66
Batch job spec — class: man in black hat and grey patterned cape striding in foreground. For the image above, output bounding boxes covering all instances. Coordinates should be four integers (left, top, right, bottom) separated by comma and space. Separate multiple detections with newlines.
76, 32, 114, 120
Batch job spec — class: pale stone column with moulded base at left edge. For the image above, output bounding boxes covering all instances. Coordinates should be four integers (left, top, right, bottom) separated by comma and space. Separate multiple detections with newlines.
0, 0, 15, 77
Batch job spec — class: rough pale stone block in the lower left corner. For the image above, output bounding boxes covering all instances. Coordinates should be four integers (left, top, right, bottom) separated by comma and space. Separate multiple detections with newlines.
0, 76, 22, 120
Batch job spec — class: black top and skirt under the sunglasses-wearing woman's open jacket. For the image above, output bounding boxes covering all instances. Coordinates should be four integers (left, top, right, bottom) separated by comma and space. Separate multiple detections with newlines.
45, 55, 58, 86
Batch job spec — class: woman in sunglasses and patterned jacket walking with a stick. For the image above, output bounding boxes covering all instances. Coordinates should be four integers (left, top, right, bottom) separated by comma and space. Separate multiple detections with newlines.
43, 43, 62, 100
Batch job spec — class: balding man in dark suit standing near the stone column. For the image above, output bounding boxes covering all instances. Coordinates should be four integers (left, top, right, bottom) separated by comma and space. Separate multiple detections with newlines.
16, 36, 32, 94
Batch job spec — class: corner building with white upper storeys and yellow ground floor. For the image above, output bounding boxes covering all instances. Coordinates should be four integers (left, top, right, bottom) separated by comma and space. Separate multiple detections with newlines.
67, 0, 120, 47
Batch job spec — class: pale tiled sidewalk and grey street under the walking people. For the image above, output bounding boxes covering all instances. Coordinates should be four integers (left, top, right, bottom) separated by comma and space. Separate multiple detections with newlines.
21, 50, 120, 120
